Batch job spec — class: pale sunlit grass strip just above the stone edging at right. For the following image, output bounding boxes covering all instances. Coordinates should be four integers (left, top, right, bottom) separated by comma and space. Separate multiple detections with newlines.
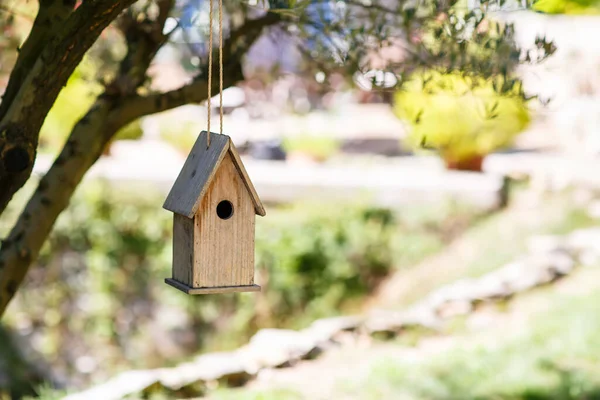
390, 192, 597, 308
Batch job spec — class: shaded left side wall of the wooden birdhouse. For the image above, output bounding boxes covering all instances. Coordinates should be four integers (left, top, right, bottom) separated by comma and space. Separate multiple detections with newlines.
173, 214, 194, 285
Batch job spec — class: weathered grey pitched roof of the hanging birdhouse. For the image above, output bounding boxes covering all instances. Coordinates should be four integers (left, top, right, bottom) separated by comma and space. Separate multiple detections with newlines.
163, 131, 265, 218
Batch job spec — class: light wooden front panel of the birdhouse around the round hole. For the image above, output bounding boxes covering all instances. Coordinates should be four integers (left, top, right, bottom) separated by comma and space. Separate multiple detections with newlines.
192, 154, 255, 288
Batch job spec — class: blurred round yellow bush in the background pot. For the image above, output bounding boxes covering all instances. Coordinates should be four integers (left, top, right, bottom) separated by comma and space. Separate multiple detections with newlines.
394, 72, 529, 161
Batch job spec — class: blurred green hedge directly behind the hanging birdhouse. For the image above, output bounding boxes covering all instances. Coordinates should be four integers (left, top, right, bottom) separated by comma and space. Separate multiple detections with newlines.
7, 184, 472, 384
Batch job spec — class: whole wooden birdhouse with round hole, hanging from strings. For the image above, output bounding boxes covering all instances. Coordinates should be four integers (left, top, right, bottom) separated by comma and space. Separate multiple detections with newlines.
163, 131, 265, 294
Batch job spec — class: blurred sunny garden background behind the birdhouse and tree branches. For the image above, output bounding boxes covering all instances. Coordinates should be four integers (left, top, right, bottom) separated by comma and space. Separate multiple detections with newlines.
0, 0, 600, 400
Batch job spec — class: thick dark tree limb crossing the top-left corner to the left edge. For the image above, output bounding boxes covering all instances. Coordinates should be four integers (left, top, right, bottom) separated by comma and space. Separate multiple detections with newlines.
0, 0, 134, 213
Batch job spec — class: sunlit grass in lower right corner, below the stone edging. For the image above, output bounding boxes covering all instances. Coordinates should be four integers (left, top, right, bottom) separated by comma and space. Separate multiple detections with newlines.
351, 293, 600, 400
